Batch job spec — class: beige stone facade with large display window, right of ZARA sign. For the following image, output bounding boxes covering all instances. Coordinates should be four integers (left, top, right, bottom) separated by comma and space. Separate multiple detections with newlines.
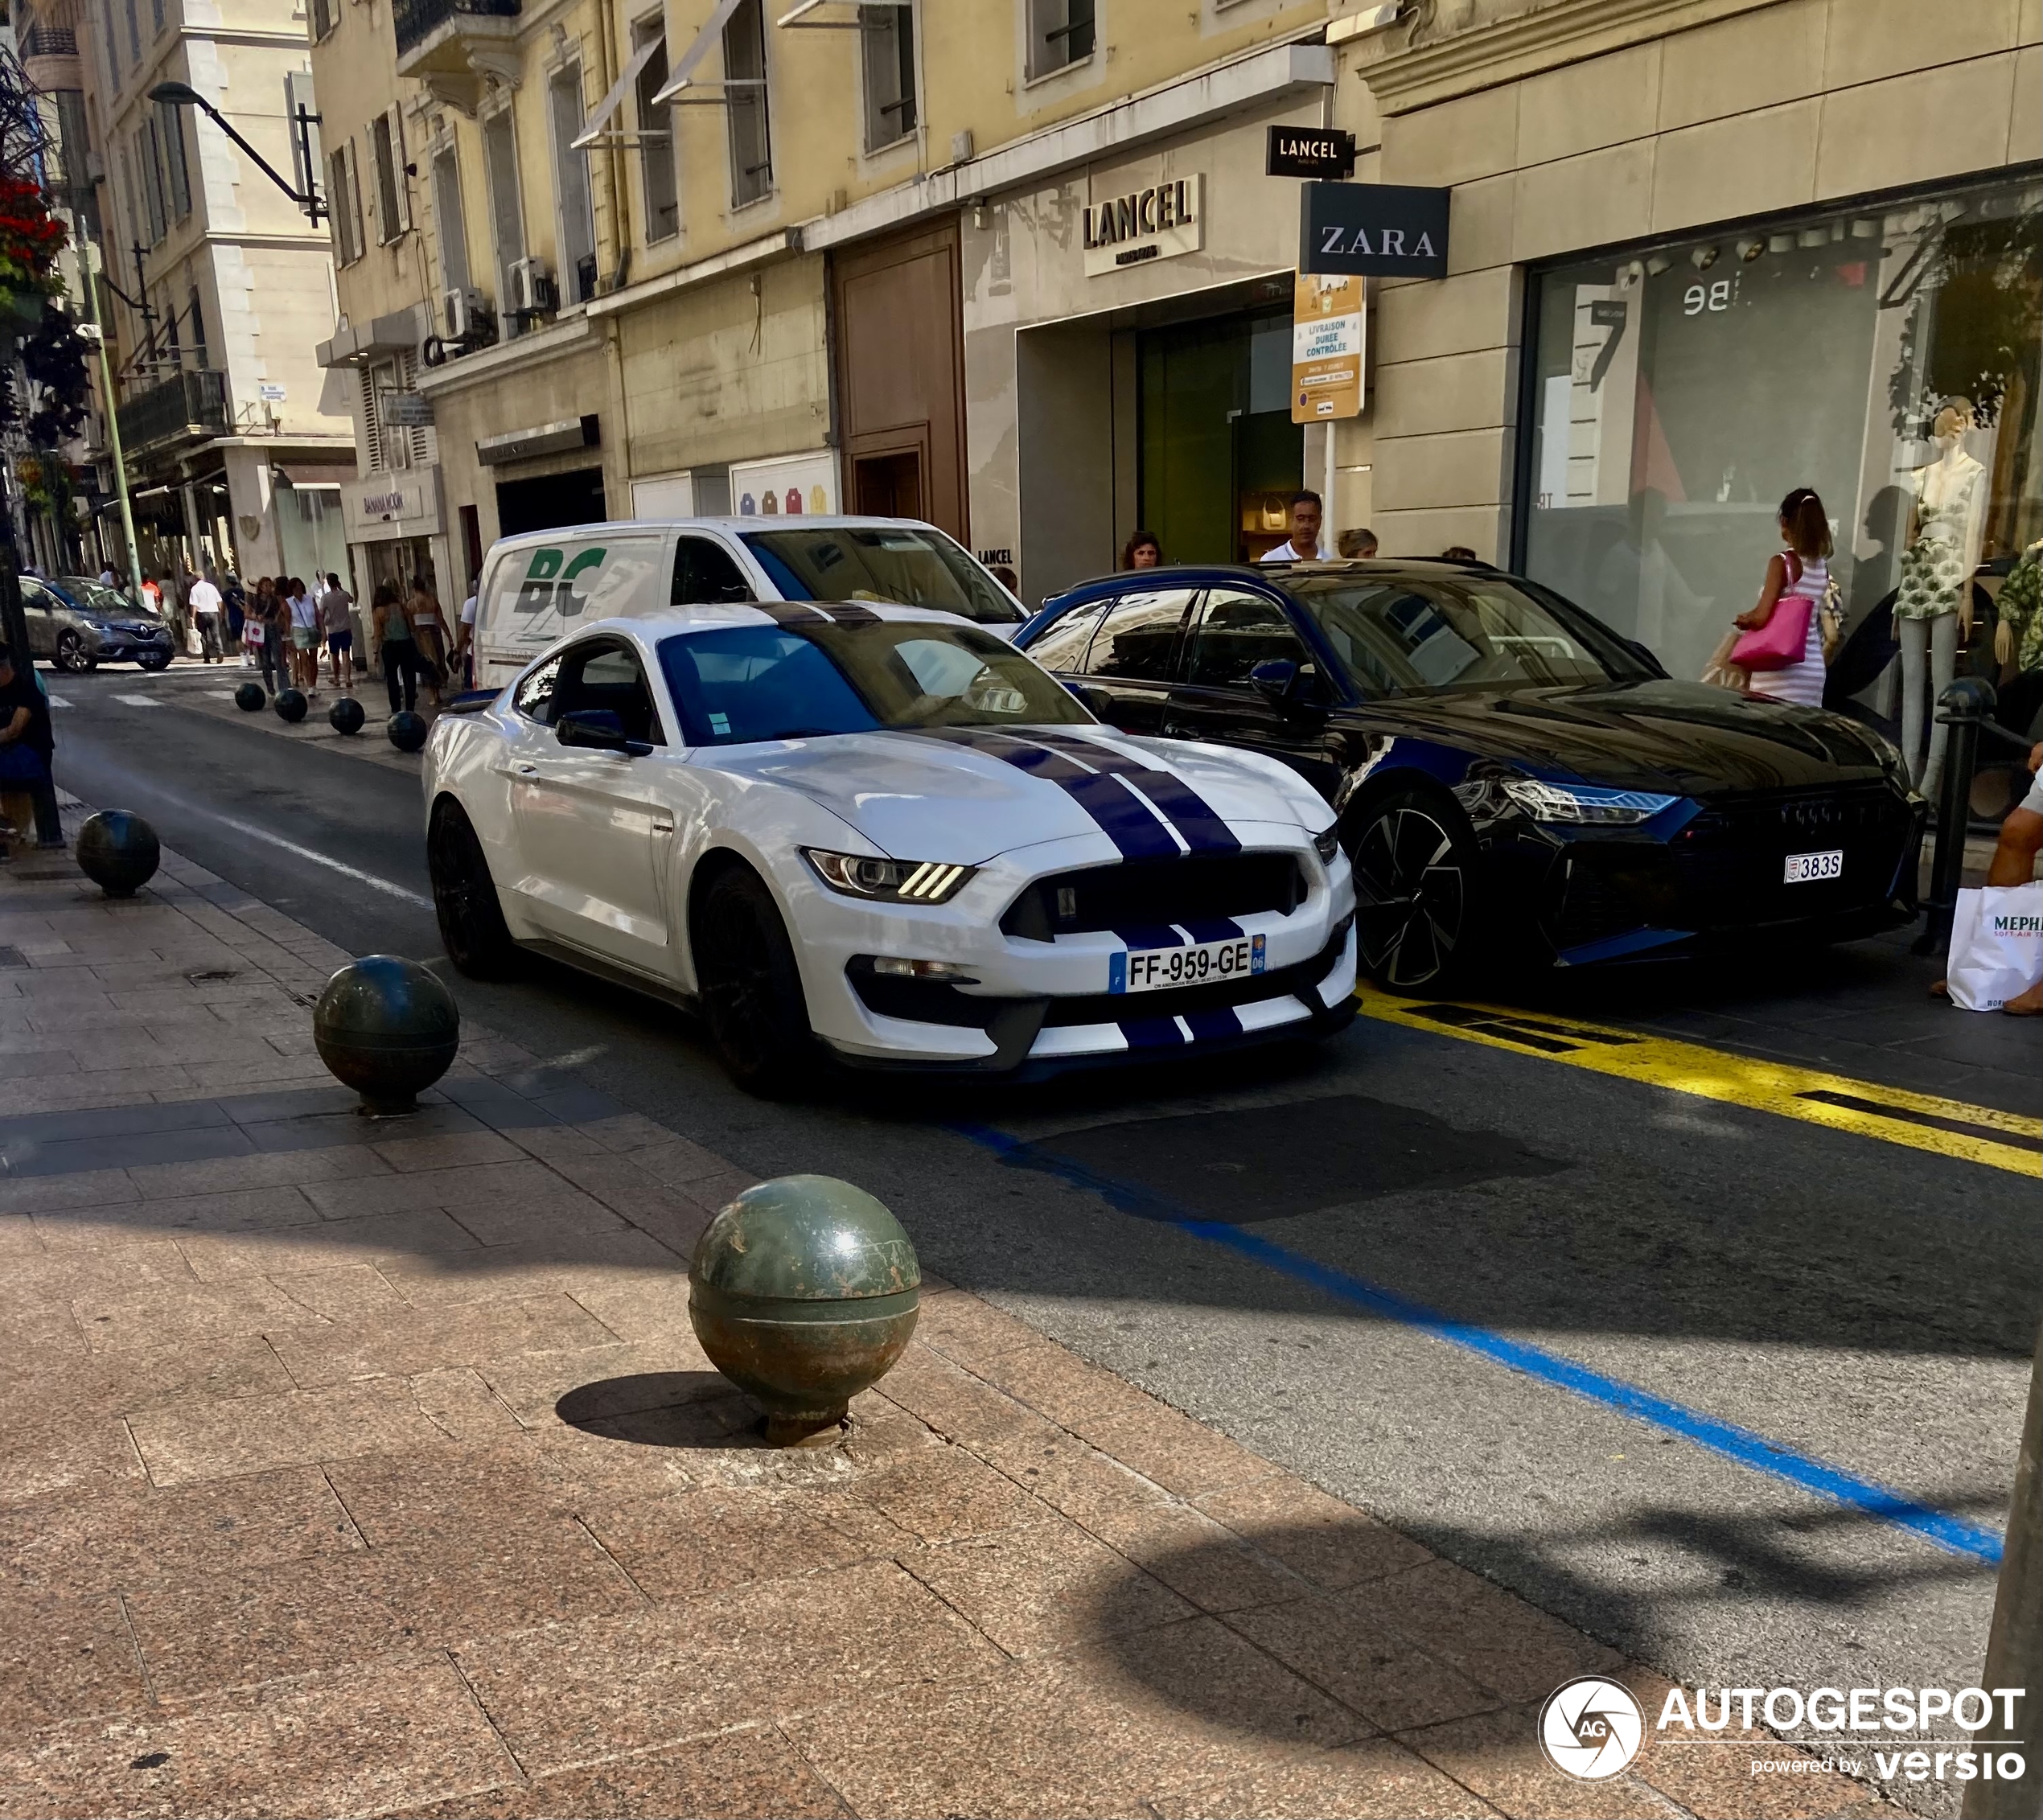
1330, 0, 2043, 676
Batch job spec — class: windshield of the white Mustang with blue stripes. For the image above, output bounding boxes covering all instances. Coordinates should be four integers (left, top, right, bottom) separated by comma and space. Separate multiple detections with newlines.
660, 619, 1089, 746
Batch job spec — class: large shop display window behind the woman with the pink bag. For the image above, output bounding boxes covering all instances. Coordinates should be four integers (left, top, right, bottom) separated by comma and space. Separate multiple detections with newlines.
1518, 175, 2043, 698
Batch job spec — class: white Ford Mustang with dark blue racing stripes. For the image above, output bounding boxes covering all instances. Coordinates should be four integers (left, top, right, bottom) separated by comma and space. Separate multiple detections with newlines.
425, 601, 1354, 1093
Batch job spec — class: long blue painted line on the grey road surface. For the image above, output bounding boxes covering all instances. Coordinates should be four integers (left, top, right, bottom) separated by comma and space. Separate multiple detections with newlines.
952, 1124, 2002, 1567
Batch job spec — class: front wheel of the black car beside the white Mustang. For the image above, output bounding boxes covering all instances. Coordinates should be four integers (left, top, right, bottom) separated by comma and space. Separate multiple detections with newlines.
1350, 791, 1475, 992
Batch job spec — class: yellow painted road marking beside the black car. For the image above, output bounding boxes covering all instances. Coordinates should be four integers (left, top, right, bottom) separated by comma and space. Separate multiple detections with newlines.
1354, 984, 2043, 1177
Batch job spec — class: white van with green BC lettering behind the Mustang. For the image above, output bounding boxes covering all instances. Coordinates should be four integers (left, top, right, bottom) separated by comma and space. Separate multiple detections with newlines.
476, 517, 1028, 688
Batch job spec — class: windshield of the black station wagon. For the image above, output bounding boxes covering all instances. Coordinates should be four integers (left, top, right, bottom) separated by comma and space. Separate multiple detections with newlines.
1289, 574, 1650, 695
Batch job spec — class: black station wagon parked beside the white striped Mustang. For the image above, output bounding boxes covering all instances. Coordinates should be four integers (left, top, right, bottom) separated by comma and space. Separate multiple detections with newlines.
1015, 561, 1922, 991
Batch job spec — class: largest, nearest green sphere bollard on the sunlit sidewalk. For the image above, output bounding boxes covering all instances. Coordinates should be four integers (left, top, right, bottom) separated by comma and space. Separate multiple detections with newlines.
689, 1174, 922, 1446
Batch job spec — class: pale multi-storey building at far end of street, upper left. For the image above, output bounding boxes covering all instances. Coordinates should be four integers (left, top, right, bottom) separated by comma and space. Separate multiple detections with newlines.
78, 0, 353, 576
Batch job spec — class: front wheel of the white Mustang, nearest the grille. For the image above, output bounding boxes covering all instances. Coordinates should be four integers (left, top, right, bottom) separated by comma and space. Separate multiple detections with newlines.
693, 866, 815, 1099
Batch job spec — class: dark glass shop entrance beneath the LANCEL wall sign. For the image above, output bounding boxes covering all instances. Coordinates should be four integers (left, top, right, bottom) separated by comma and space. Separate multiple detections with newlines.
1136, 313, 1305, 561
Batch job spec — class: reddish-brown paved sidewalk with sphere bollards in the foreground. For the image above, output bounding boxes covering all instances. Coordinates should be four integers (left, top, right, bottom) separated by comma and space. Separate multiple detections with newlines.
0, 829, 1880, 1820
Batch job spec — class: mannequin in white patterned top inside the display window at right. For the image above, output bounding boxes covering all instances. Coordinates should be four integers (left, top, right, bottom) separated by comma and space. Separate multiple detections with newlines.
1894, 398, 1986, 797
